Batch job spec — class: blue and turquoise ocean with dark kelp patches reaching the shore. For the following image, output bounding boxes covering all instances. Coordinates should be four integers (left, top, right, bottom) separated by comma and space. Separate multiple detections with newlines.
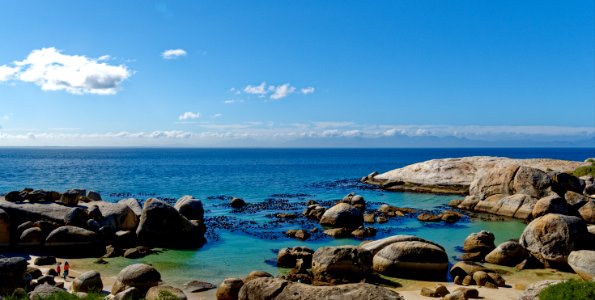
0, 148, 595, 285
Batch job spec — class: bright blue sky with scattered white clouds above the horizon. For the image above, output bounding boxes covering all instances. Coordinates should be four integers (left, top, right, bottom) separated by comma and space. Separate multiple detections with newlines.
0, 0, 595, 147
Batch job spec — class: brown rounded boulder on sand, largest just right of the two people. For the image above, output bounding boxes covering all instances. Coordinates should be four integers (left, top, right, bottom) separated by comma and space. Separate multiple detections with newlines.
112, 264, 161, 295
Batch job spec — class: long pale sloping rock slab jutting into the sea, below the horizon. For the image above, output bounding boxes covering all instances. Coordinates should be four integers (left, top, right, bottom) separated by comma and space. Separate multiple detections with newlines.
364, 156, 585, 198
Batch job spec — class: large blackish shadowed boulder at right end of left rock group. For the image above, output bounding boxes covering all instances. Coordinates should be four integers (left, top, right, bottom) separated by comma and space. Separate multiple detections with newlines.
136, 198, 204, 248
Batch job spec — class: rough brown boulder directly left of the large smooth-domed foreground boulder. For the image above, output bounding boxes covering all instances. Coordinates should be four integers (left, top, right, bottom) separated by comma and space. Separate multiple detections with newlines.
312, 246, 372, 285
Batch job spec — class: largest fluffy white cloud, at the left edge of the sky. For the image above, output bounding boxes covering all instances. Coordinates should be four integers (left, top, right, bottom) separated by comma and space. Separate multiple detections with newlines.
0, 47, 132, 95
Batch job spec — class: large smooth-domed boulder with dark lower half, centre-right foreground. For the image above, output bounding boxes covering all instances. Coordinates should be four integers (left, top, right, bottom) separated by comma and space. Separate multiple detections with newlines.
373, 241, 448, 280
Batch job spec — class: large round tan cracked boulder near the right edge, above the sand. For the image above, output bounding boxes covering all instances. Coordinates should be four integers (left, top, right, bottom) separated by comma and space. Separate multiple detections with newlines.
519, 214, 587, 268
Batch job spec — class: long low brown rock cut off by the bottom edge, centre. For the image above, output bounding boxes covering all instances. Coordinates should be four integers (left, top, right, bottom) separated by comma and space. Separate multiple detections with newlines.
238, 278, 403, 300
